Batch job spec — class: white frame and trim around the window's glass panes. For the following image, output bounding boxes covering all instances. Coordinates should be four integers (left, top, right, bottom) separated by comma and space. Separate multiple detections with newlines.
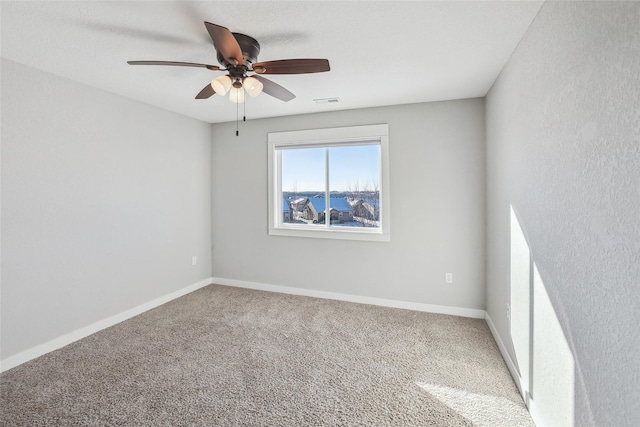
267, 124, 391, 242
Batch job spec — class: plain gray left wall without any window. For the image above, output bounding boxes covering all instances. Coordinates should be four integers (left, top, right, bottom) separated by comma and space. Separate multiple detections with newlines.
1, 59, 211, 359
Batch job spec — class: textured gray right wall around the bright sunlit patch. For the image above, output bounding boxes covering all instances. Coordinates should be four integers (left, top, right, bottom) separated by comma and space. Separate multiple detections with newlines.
486, 2, 640, 426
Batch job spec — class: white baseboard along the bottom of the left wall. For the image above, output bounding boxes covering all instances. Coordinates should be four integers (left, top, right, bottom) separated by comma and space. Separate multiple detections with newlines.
0, 277, 213, 372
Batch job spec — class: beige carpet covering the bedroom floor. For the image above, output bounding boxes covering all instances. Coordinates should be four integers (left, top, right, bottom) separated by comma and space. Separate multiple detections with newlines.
0, 285, 533, 427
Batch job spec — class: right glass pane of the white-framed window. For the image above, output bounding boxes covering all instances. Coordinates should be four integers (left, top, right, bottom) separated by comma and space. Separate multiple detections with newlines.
329, 145, 380, 228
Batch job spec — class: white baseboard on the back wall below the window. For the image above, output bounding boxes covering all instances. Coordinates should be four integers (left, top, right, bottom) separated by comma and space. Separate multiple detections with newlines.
211, 277, 485, 319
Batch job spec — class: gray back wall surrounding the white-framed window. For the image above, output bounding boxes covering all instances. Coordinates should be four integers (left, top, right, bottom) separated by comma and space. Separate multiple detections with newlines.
212, 99, 485, 309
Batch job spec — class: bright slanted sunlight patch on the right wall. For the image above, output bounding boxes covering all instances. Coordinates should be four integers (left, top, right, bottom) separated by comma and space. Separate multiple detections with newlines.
507, 206, 575, 426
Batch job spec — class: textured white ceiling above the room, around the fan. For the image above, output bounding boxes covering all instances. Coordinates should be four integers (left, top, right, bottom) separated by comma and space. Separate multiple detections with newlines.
0, 1, 543, 123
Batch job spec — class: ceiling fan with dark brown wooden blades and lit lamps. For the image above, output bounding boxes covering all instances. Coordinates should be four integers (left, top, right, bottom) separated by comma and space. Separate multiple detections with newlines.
127, 22, 330, 103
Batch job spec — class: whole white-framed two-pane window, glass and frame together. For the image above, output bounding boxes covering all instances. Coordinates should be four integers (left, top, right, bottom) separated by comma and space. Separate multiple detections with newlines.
268, 124, 390, 241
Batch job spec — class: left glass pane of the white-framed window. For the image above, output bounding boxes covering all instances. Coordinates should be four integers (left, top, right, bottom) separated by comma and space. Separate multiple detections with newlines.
281, 147, 326, 225
